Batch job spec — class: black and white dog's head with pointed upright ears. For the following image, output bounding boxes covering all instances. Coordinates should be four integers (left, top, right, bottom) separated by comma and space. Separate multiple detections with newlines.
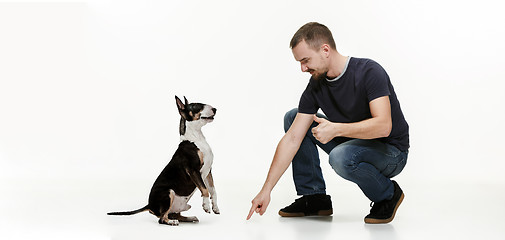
175, 96, 217, 135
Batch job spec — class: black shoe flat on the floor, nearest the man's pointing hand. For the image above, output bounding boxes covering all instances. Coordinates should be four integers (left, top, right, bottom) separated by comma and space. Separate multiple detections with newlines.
279, 194, 333, 217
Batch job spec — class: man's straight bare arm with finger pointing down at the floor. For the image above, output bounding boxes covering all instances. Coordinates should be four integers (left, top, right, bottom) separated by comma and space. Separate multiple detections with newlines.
247, 113, 314, 220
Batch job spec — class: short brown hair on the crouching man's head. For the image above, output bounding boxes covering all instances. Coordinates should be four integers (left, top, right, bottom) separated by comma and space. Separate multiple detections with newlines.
289, 22, 337, 50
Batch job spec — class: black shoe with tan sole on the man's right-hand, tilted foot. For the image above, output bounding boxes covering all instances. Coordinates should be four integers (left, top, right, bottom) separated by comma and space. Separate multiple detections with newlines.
365, 181, 405, 224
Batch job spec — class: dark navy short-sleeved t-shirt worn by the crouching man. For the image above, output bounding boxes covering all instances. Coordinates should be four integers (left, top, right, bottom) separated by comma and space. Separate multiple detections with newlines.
298, 58, 409, 151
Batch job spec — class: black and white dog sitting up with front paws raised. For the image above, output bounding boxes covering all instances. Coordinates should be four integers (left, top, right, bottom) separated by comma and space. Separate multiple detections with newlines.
107, 96, 220, 226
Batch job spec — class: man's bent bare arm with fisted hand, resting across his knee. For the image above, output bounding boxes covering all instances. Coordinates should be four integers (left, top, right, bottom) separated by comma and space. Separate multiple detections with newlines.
312, 96, 392, 144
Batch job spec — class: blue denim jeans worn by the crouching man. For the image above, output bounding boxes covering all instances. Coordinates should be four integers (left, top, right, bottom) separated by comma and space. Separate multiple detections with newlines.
284, 108, 408, 202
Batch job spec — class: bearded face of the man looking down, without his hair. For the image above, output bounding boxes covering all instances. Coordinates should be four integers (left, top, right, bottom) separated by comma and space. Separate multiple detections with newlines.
292, 41, 329, 79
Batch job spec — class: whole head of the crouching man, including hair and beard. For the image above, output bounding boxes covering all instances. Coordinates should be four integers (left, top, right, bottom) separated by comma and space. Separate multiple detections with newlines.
290, 22, 337, 79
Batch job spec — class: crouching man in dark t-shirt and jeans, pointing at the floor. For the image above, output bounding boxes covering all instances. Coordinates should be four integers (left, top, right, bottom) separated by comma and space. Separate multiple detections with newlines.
247, 22, 409, 223
